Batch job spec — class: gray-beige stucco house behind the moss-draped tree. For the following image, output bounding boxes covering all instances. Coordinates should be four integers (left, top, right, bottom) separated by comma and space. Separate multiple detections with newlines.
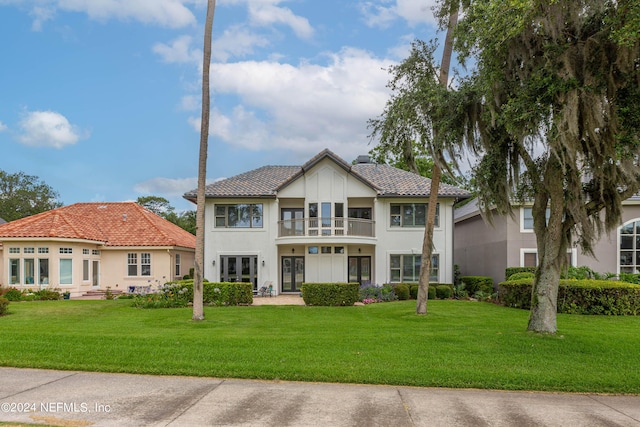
454, 196, 640, 285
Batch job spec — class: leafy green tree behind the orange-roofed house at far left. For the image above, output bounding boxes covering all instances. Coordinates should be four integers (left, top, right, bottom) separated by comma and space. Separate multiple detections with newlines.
0, 170, 62, 221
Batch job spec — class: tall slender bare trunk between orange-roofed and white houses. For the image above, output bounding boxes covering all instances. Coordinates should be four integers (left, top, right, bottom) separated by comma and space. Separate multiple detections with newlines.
192, 0, 216, 320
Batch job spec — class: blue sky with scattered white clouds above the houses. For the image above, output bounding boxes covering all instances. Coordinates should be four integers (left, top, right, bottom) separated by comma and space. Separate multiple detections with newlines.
0, 0, 444, 210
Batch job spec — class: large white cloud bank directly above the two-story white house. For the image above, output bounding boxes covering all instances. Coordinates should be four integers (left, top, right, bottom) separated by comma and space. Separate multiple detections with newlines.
189, 49, 392, 162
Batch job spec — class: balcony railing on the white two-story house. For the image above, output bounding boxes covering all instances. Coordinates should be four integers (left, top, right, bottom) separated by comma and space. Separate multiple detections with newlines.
278, 218, 375, 237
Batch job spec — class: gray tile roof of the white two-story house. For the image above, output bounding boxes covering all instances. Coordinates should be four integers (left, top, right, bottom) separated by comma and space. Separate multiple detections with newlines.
184, 150, 469, 201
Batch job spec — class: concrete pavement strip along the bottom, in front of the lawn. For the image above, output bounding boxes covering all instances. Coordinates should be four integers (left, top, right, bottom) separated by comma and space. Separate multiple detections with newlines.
0, 368, 640, 427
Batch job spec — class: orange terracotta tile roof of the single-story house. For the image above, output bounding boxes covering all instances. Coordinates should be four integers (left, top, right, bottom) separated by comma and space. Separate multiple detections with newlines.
0, 202, 196, 248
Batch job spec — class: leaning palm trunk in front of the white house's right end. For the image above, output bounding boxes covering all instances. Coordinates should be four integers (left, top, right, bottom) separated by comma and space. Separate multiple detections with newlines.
416, 8, 458, 314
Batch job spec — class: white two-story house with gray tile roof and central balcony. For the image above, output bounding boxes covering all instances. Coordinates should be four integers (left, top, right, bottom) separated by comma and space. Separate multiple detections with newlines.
185, 150, 469, 293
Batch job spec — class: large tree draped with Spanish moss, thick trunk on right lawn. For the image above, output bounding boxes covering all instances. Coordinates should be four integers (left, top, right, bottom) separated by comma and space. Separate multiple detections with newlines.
430, 0, 640, 333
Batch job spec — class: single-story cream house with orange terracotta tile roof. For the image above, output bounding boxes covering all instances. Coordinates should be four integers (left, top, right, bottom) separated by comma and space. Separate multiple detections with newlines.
0, 202, 195, 297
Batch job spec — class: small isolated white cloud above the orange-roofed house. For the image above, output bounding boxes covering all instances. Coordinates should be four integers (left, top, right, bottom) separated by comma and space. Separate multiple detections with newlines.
18, 111, 88, 148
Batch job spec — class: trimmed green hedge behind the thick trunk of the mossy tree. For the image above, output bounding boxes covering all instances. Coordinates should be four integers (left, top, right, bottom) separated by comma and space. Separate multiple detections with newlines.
498, 279, 640, 315
